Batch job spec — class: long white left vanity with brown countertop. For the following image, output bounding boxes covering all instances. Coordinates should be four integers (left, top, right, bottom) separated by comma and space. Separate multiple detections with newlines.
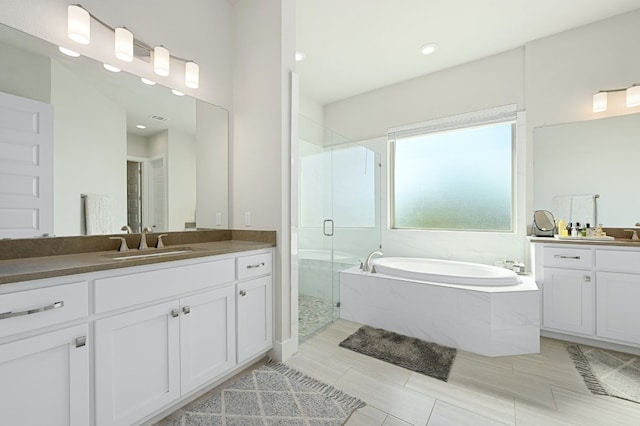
0, 231, 274, 426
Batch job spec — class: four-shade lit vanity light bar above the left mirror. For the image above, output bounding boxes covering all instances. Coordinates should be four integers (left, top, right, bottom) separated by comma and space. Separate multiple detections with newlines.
67, 4, 200, 89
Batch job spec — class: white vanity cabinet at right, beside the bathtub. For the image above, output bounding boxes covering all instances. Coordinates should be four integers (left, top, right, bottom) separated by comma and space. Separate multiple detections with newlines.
531, 238, 640, 353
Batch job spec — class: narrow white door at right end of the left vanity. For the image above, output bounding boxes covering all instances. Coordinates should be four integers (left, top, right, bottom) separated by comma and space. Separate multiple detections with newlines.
236, 276, 273, 363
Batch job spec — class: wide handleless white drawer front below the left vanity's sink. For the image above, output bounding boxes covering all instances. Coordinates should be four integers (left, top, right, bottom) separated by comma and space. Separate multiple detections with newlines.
95, 259, 235, 313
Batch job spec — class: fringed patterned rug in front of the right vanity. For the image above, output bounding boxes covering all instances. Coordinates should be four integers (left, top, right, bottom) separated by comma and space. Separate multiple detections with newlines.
566, 344, 640, 403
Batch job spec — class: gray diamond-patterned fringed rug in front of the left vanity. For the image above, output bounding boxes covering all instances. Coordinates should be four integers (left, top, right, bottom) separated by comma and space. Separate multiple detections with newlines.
157, 362, 365, 426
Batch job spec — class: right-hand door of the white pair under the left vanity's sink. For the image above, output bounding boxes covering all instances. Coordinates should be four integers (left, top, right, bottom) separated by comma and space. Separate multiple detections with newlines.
180, 285, 236, 394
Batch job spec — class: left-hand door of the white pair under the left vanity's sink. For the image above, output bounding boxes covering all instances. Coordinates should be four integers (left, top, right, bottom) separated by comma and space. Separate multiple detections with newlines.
95, 301, 180, 426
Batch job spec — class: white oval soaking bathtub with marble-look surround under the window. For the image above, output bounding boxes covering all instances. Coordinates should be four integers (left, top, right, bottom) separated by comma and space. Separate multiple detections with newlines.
340, 257, 540, 356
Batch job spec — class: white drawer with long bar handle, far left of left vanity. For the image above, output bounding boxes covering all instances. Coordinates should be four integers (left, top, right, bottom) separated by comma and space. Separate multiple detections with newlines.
0, 281, 89, 337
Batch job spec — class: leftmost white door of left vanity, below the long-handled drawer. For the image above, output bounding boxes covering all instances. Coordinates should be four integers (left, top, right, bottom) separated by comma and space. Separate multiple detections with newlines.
0, 324, 89, 426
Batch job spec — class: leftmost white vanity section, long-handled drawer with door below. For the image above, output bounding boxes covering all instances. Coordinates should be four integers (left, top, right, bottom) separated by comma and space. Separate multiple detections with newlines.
0, 280, 90, 426
